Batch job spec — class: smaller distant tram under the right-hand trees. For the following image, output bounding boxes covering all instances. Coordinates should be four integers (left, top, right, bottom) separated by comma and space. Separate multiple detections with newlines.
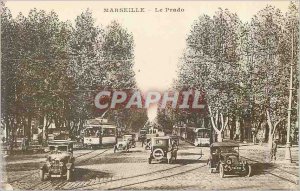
186, 127, 210, 147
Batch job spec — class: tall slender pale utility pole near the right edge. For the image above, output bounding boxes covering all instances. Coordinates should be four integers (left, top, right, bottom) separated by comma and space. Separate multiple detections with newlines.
285, 29, 294, 163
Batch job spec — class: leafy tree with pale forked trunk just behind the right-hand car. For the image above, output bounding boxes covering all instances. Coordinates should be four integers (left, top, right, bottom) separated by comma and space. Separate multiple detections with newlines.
178, 9, 241, 141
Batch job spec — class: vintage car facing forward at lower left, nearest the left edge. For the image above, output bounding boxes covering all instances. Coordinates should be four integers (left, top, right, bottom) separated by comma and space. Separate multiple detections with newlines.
40, 140, 75, 181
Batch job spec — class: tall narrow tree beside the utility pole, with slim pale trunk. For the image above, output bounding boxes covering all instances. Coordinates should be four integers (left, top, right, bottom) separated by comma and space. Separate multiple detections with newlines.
246, 6, 298, 152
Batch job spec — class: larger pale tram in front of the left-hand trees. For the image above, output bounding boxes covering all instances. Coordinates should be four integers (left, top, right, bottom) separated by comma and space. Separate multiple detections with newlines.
83, 118, 117, 148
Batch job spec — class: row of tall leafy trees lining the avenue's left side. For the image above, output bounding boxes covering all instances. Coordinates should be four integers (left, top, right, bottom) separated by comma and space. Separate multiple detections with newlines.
1, 7, 147, 145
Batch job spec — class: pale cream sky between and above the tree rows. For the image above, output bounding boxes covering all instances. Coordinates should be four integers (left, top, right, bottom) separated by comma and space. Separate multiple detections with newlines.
6, 1, 289, 120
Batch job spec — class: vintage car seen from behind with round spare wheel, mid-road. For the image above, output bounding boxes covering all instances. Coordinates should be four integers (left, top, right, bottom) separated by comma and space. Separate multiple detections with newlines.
148, 136, 178, 164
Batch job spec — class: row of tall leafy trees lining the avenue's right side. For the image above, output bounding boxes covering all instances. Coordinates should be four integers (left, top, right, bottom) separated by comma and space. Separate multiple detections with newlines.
168, 3, 299, 154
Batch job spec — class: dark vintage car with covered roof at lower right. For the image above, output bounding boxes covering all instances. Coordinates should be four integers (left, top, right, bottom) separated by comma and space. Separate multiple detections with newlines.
208, 142, 251, 178
